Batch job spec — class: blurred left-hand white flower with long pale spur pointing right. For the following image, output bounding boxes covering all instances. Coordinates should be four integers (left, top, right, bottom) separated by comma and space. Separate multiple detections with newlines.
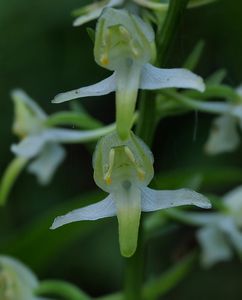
11, 90, 114, 184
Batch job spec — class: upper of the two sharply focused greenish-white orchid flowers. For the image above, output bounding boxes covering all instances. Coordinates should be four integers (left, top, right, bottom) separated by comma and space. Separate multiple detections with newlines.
52, 8, 204, 140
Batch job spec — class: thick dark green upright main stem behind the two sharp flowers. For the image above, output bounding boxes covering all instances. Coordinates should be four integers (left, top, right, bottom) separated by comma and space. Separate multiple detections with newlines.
124, 0, 188, 300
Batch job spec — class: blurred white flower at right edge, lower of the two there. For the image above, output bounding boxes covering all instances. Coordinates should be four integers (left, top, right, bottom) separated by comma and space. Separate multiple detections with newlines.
172, 186, 242, 267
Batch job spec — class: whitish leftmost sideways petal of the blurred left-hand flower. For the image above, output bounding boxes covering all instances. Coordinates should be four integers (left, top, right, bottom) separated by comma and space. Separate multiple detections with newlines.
11, 133, 46, 158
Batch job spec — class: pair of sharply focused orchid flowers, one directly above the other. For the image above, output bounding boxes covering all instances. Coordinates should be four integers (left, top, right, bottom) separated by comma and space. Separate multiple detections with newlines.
51, 7, 211, 257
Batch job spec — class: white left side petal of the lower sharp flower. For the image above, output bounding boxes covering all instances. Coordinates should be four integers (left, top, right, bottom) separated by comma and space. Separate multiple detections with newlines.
51, 195, 116, 229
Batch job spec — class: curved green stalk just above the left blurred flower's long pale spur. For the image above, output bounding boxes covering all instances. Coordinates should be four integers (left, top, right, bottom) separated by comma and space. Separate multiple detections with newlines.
46, 111, 103, 129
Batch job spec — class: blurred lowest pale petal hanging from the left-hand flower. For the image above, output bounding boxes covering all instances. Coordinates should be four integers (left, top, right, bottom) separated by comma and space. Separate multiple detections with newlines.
28, 143, 65, 185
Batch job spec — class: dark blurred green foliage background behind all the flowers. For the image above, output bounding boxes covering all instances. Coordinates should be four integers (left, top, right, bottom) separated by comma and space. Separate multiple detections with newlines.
0, 0, 242, 300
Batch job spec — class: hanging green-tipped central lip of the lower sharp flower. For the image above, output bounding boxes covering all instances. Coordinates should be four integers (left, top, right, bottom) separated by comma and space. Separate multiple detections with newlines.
112, 180, 141, 257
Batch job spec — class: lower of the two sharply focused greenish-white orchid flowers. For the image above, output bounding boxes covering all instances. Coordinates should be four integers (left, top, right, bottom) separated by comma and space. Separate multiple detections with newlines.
51, 131, 210, 257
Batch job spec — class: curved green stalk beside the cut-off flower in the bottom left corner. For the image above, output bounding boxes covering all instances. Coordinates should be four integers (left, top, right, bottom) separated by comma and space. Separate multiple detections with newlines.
35, 280, 91, 300
